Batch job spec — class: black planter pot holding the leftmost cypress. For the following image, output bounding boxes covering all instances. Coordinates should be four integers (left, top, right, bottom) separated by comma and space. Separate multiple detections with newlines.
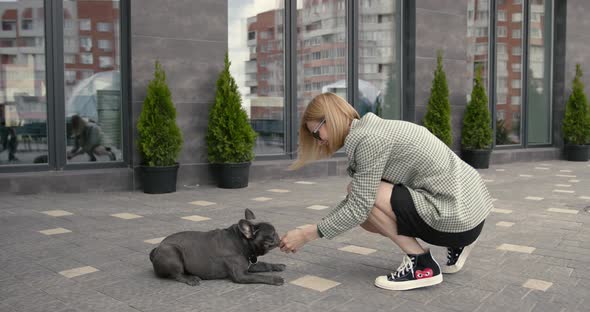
141, 164, 178, 194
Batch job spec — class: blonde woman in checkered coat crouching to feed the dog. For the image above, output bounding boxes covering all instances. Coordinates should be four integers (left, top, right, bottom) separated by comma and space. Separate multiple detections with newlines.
281, 93, 492, 290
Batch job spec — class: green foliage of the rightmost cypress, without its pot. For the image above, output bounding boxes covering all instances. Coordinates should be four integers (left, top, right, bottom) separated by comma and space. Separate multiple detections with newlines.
563, 64, 590, 145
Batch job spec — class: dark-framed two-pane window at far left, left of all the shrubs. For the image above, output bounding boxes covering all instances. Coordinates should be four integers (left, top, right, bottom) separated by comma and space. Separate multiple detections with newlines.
0, 0, 124, 168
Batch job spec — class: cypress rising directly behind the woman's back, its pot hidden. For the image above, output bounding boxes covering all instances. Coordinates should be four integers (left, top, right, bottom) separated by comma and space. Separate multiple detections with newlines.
423, 50, 453, 146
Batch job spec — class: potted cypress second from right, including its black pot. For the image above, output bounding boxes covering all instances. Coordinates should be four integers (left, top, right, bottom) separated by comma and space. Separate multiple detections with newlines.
461, 66, 492, 169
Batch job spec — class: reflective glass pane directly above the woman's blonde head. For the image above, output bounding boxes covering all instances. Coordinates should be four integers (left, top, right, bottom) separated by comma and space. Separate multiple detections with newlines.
297, 0, 346, 125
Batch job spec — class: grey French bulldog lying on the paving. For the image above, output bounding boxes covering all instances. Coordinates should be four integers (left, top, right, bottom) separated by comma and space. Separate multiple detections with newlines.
150, 209, 286, 286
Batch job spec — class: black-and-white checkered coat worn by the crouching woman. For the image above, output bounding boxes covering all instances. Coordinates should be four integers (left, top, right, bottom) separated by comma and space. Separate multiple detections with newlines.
318, 113, 492, 239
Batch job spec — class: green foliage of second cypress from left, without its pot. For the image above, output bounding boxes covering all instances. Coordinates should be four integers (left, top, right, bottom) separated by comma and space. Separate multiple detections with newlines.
207, 53, 256, 163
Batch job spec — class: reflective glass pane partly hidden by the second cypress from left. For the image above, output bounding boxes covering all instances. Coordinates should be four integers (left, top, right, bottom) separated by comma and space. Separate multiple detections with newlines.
228, 0, 285, 155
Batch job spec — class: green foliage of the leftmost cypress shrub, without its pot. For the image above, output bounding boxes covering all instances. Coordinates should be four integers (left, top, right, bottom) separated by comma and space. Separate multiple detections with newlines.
137, 61, 182, 167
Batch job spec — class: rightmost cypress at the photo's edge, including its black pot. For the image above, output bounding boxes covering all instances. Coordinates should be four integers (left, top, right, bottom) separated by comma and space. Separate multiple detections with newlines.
563, 64, 590, 161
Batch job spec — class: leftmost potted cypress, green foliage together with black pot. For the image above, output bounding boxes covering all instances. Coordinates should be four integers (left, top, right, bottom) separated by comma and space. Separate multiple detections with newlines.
137, 61, 182, 194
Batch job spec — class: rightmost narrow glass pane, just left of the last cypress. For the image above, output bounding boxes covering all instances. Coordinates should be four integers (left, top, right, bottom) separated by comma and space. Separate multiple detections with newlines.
527, 0, 552, 144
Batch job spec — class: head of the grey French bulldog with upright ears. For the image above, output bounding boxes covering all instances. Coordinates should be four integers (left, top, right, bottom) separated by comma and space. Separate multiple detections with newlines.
238, 209, 281, 256
